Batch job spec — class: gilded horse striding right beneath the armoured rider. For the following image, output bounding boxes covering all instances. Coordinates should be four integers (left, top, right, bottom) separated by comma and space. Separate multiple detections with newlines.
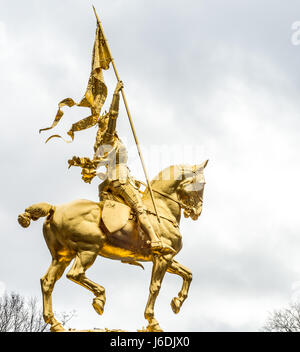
18, 160, 208, 331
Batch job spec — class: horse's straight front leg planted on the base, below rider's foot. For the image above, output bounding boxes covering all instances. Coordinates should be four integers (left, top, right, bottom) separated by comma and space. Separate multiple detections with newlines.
144, 255, 171, 332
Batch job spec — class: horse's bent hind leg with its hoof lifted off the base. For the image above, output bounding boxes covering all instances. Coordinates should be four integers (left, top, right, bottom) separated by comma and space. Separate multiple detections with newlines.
67, 251, 105, 315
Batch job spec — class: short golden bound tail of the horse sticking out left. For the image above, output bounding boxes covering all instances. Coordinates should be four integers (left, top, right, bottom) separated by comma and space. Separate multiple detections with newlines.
18, 203, 55, 227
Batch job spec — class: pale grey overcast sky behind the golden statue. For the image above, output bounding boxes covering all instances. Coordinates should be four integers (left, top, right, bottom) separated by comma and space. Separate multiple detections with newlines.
0, 0, 300, 331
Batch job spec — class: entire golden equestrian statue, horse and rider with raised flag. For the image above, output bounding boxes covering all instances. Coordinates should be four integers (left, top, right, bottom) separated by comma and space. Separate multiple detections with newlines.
18, 8, 208, 331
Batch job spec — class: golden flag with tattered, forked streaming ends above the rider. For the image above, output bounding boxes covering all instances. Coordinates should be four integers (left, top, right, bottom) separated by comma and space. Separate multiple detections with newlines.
40, 23, 111, 143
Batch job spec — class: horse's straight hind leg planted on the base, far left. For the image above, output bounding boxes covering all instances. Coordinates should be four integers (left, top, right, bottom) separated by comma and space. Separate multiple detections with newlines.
41, 259, 70, 331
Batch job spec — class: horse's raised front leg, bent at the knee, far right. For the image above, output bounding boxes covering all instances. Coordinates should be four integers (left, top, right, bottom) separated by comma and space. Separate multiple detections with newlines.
168, 260, 193, 314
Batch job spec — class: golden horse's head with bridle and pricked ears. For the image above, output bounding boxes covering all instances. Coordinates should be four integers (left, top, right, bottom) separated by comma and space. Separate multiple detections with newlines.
177, 160, 208, 220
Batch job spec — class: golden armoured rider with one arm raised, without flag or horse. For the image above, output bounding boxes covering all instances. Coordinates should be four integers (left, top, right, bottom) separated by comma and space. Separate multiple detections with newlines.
69, 82, 174, 254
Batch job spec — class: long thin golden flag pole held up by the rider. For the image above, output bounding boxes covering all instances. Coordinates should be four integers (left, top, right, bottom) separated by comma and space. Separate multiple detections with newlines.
93, 6, 160, 222
